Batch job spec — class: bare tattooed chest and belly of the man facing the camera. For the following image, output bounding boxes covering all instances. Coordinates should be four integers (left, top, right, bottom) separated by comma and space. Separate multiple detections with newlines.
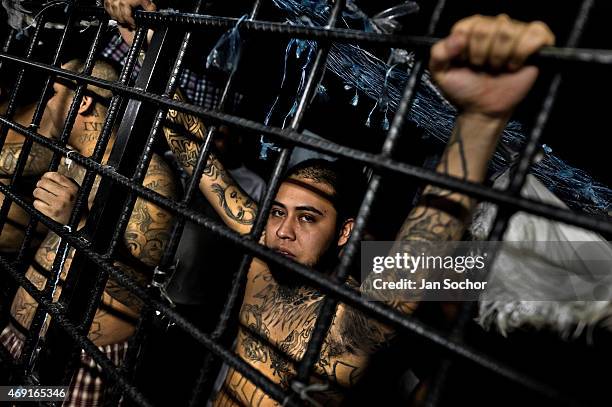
215, 259, 391, 407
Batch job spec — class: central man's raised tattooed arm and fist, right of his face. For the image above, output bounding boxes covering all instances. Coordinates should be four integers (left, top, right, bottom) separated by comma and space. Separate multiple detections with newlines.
330, 16, 554, 366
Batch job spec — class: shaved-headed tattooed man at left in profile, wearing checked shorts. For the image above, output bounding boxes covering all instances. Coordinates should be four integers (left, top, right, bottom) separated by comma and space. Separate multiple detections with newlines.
0, 60, 175, 407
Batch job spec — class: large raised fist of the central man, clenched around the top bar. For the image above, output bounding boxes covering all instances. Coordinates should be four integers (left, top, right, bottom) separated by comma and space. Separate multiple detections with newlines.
429, 14, 555, 119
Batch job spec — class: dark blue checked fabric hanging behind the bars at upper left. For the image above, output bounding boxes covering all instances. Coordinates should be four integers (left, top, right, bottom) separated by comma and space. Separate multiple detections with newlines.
102, 33, 242, 110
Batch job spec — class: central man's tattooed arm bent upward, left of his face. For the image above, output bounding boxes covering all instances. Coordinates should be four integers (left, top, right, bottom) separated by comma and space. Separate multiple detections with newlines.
164, 92, 257, 234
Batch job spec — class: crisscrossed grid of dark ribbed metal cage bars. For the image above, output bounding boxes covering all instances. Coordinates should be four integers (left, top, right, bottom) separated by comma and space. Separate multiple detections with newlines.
0, 0, 612, 405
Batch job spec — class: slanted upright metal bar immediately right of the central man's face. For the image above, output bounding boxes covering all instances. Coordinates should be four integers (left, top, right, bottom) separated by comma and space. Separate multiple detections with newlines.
296, 0, 446, 383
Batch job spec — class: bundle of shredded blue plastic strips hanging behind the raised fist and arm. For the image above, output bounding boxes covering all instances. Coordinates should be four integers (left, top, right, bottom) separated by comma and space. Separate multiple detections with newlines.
232, 0, 612, 216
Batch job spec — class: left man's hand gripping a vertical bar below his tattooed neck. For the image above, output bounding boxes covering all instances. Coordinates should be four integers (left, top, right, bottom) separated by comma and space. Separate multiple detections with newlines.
33, 172, 79, 225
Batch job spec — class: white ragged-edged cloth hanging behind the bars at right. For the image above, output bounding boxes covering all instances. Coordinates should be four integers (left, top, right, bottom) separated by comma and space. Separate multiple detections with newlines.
470, 172, 612, 337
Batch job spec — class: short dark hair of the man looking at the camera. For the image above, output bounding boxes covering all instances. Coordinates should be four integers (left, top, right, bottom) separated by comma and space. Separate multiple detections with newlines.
285, 158, 366, 224
